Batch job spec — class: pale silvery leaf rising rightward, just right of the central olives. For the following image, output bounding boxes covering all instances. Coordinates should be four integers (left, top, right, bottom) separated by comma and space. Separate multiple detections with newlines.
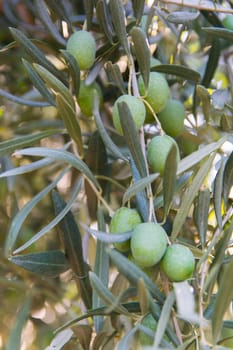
177, 135, 228, 175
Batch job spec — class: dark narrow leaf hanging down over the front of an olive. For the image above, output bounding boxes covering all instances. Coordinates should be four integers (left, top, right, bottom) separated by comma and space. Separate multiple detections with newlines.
118, 102, 147, 177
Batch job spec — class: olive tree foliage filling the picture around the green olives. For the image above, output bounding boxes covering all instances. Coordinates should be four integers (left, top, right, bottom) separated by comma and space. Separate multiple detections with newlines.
0, 0, 233, 350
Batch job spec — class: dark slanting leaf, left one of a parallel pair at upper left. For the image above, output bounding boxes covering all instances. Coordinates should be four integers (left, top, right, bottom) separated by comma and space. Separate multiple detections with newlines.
22, 58, 56, 106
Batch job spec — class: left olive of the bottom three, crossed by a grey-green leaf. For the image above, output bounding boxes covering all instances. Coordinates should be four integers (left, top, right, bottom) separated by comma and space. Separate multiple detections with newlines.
109, 207, 142, 252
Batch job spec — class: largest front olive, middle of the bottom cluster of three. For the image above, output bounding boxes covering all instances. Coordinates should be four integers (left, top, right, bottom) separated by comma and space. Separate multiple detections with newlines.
130, 222, 167, 267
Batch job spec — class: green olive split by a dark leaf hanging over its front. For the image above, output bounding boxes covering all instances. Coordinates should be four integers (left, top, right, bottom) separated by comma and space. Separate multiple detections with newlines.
112, 95, 146, 135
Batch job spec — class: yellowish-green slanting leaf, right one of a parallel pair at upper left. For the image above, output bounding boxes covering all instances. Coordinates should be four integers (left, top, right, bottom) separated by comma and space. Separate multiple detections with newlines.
33, 63, 75, 110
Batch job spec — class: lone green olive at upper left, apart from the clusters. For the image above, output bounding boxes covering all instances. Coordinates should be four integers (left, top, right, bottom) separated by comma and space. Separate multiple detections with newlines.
66, 30, 96, 70
